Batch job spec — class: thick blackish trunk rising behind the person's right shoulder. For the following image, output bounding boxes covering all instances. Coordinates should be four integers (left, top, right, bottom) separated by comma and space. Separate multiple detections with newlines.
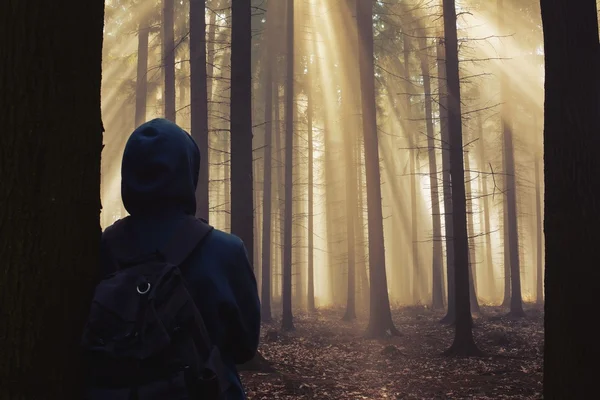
231, 0, 254, 268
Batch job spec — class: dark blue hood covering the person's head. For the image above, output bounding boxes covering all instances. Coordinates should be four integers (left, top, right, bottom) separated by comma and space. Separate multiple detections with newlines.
121, 118, 200, 216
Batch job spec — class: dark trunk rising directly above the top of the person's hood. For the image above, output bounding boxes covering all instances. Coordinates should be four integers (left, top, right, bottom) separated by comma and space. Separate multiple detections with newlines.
162, 0, 176, 122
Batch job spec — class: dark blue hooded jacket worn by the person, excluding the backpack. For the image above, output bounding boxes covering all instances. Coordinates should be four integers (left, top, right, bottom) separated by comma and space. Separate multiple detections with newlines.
101, 119, 260, 400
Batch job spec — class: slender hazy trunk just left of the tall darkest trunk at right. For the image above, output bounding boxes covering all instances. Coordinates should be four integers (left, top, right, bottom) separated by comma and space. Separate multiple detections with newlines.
420, 32, 444, 310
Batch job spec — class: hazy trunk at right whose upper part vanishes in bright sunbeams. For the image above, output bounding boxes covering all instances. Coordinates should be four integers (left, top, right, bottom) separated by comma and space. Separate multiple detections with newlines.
498, 0, 524, 317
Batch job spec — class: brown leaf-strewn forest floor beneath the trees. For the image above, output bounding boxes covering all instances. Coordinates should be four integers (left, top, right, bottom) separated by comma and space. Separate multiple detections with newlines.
242, 307, 544, 400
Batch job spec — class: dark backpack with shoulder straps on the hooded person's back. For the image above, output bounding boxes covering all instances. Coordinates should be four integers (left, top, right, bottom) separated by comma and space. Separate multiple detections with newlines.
82, 217, 229, 400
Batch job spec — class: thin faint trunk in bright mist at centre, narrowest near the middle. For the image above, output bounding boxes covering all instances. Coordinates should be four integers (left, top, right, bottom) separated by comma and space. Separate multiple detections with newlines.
306, 66, 315, 311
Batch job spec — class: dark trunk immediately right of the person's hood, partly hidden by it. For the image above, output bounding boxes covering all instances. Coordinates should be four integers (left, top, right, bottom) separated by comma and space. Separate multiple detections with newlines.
190, 0, 209, 220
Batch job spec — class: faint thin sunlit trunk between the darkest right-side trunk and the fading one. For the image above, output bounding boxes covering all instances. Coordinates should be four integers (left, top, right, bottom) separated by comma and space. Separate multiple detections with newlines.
477, 113, 496, 299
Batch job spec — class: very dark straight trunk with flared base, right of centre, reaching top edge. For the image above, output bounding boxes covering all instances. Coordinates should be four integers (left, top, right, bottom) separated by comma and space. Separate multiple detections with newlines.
443, 0, 480, 356
